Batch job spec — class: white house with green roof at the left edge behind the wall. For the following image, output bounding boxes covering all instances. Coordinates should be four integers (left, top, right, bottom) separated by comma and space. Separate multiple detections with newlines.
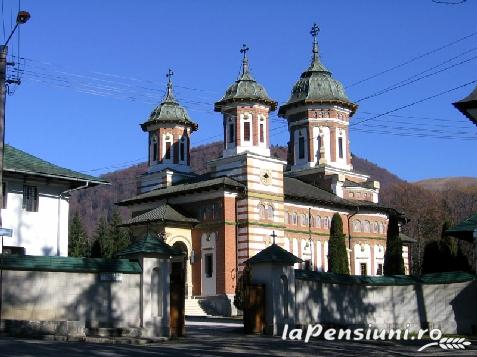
0, 145, 107, 256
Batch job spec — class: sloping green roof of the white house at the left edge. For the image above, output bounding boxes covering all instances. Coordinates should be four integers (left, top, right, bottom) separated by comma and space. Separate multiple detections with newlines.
4, 144, 107, 184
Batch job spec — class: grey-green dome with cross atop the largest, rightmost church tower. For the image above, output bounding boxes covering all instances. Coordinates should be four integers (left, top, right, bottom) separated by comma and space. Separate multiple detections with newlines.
278, 24, 358, 116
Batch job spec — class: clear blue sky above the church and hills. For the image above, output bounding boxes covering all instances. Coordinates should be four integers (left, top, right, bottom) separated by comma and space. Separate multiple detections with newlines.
0, 0, 477, 181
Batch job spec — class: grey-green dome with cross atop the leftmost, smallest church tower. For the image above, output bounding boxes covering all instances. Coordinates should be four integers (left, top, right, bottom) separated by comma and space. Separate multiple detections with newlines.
141, 70, 198, 131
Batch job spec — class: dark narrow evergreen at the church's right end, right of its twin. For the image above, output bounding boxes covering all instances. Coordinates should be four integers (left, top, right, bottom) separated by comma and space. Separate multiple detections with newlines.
383, 214, 404, 275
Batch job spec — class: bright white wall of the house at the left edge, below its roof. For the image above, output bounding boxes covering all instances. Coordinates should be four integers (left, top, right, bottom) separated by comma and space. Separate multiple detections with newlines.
0, 179, 69, 256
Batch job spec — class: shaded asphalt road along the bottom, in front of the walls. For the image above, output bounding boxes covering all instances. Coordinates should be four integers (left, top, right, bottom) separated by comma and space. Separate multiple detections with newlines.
0, 321, 477, 357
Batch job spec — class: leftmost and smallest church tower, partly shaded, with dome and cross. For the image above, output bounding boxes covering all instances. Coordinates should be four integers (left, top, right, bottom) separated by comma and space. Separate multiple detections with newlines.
138, 69, 198, 193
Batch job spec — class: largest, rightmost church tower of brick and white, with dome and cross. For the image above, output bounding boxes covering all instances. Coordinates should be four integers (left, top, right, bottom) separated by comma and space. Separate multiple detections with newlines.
278, 24, 357, 171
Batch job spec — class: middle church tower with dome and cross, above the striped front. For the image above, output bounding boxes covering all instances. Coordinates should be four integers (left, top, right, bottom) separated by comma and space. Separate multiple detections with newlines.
215, 45, 277, 157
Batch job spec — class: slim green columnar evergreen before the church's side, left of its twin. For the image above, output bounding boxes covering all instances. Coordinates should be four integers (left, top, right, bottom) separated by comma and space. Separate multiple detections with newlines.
328, 213, 349, 274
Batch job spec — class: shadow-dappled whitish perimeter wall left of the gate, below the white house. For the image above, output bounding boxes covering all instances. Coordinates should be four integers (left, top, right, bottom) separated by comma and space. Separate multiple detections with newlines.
2, 270, 141, 327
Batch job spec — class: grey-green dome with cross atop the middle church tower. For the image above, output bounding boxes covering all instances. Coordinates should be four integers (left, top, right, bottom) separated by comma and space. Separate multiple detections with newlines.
214, 45, 277, 112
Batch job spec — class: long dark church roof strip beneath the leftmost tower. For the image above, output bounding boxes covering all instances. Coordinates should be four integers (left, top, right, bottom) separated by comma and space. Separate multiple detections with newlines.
117, 177, 244, 206
